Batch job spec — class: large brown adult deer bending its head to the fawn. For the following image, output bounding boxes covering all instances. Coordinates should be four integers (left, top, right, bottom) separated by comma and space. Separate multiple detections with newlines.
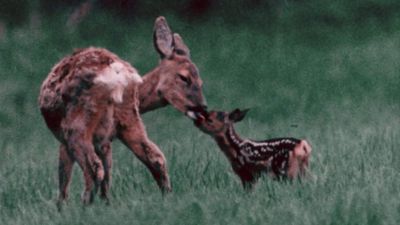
39, 17, 206, 205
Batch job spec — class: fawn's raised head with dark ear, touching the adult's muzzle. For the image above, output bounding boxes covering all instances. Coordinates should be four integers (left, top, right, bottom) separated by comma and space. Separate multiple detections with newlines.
195, 109, 249, 136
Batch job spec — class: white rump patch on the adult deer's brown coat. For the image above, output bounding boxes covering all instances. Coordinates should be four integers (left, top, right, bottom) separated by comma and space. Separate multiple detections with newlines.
94, 62, 143, 103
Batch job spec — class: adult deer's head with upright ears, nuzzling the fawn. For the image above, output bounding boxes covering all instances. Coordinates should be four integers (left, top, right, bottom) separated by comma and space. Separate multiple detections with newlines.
154, 17, 207, 118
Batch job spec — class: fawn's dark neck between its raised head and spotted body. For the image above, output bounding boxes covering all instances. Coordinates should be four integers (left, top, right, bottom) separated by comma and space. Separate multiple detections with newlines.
214, 125, 243, 162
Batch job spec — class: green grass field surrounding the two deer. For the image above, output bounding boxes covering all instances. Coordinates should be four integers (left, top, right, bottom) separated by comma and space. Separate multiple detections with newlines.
0, 7, 400, 225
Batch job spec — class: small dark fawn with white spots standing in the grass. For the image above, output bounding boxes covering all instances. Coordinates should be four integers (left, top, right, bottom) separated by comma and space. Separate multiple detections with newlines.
195, 109, 311, 188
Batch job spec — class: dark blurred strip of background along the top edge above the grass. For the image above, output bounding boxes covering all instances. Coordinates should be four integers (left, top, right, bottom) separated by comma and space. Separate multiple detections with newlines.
0, 0, 400, 31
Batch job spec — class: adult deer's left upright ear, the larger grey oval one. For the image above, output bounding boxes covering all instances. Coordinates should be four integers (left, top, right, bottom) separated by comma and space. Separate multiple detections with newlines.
153, 16, 174, 58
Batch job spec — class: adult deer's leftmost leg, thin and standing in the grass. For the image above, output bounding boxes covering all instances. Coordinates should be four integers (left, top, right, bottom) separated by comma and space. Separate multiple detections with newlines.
57, 144, 74, 210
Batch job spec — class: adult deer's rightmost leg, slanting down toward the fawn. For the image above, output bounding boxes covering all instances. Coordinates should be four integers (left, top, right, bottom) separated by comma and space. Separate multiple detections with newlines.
118, 114, 171, 194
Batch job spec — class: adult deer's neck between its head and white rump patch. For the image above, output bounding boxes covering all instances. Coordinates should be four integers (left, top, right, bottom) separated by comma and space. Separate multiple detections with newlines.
139, 68, 168, 113
